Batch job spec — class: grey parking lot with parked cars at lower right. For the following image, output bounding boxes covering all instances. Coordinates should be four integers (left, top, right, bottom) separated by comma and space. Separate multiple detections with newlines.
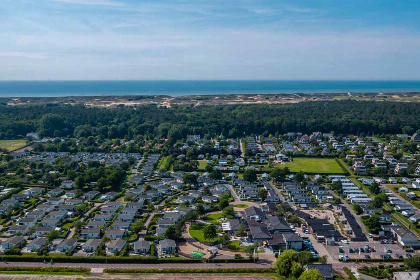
325, 242, 415, 260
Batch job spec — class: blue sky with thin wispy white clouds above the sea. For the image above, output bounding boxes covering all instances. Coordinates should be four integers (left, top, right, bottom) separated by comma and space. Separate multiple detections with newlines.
0, 0, 420, 80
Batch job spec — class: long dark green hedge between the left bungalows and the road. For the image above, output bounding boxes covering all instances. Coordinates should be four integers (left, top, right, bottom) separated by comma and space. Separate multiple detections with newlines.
2, 255, 201, 263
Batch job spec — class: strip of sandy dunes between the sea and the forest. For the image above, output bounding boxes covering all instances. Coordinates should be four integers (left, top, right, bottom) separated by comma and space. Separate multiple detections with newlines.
0, 92, 420, 108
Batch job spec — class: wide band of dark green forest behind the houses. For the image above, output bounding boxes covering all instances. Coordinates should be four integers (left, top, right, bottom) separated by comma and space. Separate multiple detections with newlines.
0, 100, 420, 143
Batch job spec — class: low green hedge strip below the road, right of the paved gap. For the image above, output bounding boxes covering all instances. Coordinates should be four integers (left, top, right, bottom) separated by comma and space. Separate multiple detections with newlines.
104, 268, 276, 274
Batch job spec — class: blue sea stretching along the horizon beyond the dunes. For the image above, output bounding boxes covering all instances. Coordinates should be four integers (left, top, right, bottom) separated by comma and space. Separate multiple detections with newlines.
0, 81, 420, 97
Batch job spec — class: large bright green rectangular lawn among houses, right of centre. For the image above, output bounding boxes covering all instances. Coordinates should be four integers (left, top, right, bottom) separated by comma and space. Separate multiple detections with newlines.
279, 157, 345, 174
